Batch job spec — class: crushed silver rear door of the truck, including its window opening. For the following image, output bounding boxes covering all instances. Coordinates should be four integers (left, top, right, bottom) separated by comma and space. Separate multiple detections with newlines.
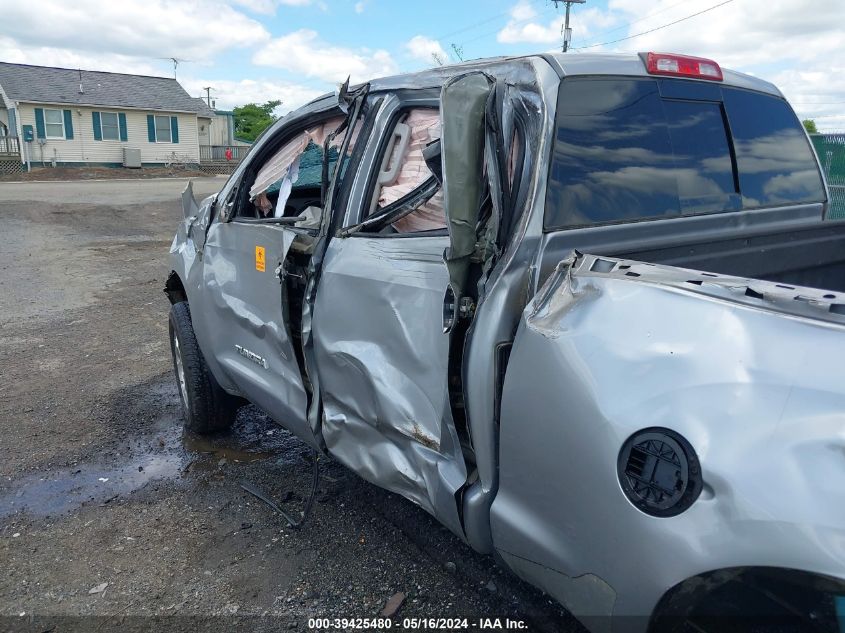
313, 79, 488, 537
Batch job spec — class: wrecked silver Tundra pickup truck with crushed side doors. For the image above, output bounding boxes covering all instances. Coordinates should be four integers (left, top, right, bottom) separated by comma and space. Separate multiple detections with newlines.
166, 53, 845, 631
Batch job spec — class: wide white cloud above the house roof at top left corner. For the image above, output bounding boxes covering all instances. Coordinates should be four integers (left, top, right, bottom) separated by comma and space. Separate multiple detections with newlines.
3, 0, 270, 63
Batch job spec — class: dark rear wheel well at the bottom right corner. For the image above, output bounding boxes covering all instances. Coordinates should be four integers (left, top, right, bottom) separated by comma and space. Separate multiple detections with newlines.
649, 567, 845, 633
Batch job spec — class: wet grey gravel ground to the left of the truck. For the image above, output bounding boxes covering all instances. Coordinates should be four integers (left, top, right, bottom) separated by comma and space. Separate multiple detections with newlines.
0, 178, 582, 632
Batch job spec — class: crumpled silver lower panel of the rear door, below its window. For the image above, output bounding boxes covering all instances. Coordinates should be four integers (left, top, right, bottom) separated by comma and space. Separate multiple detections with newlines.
313, 236, 467, 535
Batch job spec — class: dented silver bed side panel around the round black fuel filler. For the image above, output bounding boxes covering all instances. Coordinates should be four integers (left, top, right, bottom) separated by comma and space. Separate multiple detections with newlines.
492, 255, 845, 630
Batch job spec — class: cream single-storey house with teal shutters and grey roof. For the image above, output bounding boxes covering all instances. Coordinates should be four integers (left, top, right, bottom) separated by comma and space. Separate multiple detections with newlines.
0, 62, 215, 166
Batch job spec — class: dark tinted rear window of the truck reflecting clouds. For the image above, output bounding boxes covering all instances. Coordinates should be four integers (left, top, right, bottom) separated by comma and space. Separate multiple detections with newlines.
545, 78, 824, 228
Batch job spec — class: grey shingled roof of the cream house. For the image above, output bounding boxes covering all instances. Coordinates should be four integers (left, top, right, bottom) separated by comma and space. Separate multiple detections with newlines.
0, 62, 213, 117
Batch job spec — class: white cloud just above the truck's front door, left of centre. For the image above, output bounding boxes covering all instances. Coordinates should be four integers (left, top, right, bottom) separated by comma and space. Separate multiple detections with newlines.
252, 29, 399, 82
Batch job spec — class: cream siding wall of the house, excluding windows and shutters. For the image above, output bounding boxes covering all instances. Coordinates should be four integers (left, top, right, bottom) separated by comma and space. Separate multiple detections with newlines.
18, 103, 199, 165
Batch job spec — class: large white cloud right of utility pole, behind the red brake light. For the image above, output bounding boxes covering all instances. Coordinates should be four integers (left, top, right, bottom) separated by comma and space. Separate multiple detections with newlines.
608, 0, 845, 130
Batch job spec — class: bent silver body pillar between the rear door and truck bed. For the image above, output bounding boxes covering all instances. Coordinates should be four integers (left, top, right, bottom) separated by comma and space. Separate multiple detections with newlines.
463, 61, 557, 552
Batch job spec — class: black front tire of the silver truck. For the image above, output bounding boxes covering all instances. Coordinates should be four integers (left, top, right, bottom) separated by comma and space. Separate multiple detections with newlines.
169, 301, 241, 435
